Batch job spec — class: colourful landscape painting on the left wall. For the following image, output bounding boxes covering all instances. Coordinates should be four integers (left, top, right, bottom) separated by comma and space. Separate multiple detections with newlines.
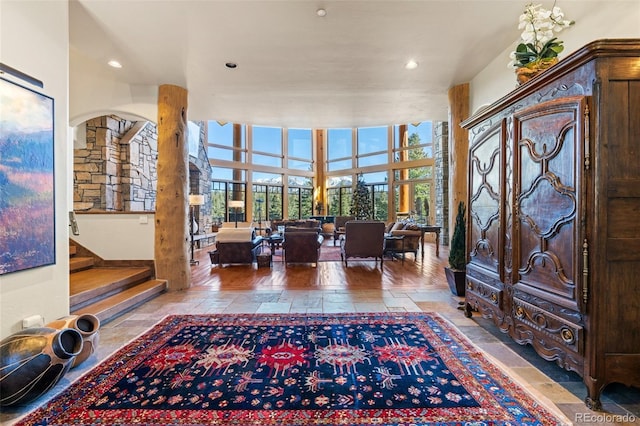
0, 78, 56, 275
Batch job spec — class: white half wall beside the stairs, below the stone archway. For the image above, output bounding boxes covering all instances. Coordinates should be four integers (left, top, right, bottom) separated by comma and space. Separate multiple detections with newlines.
71, 213, 155, 260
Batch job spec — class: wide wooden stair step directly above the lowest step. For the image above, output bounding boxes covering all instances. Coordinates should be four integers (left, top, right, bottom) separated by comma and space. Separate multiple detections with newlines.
69, 267, 151, 310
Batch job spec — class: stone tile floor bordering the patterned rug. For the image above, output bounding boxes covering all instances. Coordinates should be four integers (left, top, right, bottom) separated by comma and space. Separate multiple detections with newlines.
0, 245, 640, 425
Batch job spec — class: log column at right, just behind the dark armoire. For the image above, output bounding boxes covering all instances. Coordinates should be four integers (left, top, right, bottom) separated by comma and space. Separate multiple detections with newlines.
449, 83, 469, 241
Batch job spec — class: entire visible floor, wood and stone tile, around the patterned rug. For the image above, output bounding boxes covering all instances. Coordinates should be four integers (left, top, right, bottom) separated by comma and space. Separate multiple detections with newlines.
0, 241, 640, 425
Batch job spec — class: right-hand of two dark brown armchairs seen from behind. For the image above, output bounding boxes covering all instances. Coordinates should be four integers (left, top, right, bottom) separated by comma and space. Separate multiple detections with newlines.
340, 220, 384, 268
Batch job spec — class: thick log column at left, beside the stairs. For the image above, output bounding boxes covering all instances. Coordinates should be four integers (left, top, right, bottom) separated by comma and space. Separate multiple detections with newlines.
155, 84, 191, 291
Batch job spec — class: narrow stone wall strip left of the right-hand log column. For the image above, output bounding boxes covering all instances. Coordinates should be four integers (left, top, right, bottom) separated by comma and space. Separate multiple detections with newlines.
433, 121, 449, 246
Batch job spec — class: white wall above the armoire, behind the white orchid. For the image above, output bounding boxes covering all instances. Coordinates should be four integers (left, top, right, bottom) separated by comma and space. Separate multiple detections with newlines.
469, 0, 640, 114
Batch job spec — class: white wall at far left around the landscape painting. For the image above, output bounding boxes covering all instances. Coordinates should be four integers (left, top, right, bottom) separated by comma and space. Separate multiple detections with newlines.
0, 0, 71, 338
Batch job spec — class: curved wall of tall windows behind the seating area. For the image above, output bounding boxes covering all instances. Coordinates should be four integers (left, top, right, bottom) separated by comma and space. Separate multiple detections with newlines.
208, 121, 435, 222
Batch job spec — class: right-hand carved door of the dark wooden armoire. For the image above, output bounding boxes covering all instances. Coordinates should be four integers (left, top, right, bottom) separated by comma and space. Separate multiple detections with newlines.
513, 97, 588, 320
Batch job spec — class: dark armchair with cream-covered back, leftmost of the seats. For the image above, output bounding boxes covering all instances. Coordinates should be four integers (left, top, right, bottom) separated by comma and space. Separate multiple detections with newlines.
209, 227, 262, 265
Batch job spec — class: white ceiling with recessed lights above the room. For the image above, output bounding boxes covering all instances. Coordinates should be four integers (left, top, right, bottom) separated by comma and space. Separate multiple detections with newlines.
70, 0, 606, 128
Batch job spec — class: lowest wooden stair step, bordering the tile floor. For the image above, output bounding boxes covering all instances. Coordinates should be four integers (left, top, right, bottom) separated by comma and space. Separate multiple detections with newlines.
72, 280, 167, 323
